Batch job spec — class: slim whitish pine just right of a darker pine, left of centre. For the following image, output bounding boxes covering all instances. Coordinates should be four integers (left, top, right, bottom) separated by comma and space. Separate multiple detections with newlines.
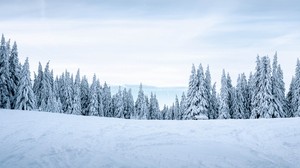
89, 74, 99, 116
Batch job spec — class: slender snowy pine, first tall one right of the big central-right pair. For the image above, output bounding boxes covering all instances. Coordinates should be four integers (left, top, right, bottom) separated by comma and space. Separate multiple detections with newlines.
218, 70, 230, 119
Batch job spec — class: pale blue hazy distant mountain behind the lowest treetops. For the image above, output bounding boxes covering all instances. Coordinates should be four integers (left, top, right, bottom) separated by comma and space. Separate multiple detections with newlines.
111, 85, 187, 108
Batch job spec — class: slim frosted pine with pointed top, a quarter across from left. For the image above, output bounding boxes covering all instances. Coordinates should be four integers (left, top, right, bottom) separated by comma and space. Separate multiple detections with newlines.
72, 69, 81, 115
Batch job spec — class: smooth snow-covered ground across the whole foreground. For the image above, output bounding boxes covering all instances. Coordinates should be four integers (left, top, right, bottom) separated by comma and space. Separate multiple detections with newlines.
0, 109, 300, 168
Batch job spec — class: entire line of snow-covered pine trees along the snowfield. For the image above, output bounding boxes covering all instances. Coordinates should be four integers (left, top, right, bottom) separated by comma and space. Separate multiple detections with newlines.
0, 35, 300, 120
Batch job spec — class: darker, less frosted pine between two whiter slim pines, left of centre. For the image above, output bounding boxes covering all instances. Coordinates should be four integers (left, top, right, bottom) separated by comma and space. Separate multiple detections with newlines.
80, 76, 90, 115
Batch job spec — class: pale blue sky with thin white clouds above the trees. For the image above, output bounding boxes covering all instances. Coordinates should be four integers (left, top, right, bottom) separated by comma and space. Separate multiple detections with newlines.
0, 0, 300, 87
